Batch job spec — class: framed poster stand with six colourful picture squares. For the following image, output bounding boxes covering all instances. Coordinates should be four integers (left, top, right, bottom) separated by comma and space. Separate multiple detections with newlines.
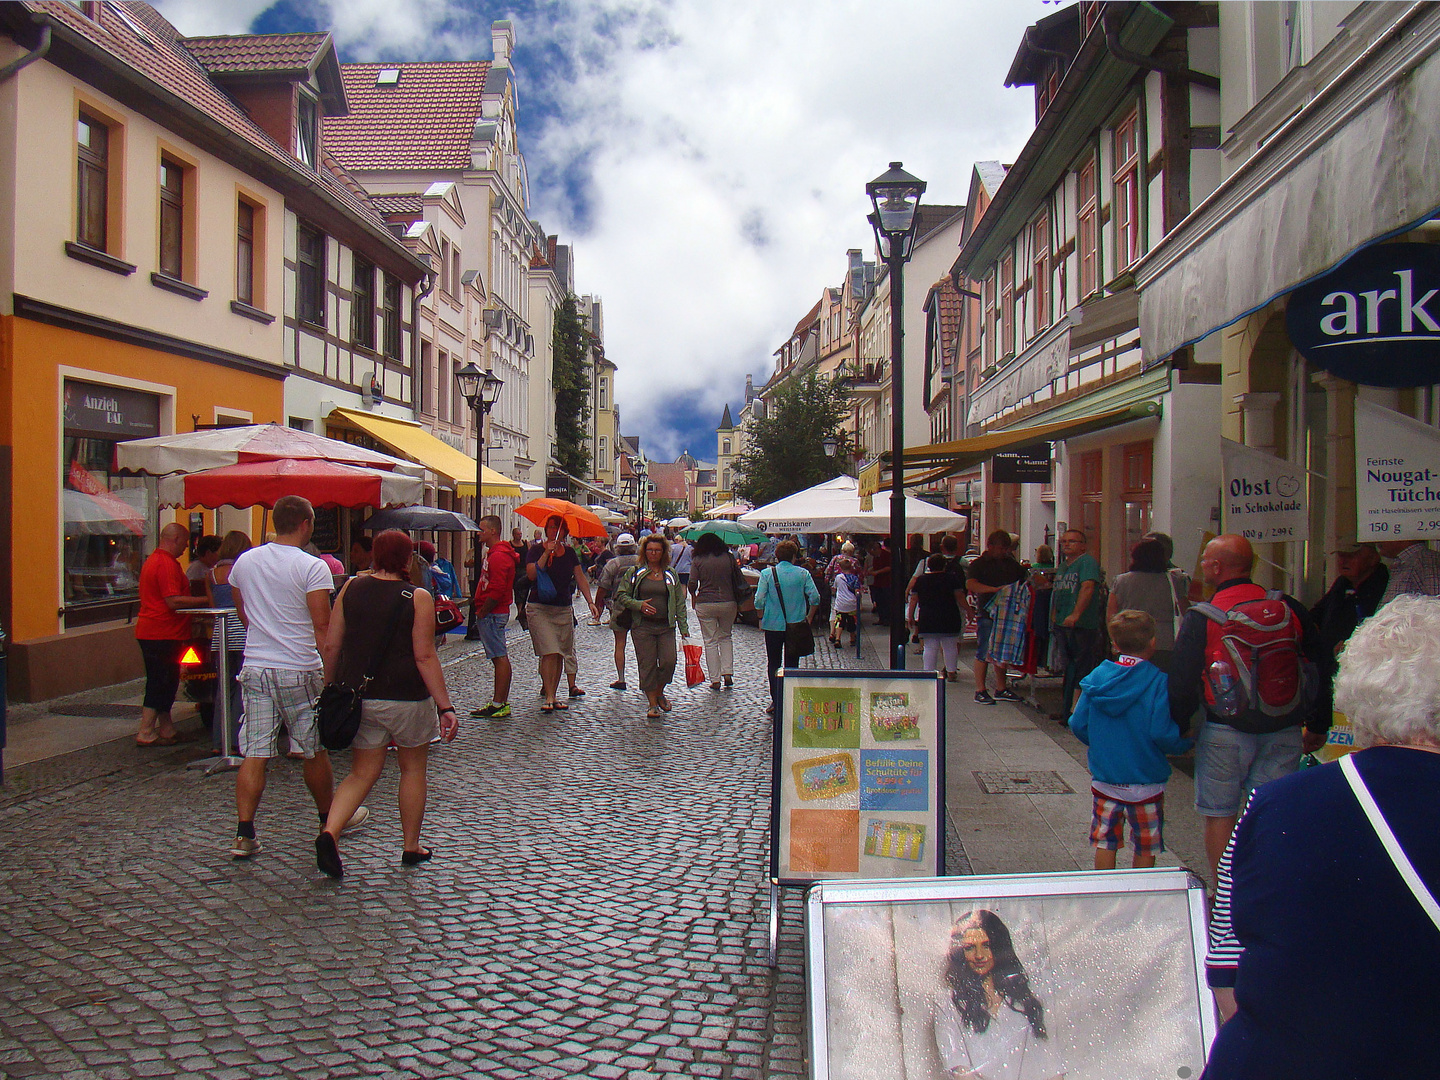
770, 668, 945, 886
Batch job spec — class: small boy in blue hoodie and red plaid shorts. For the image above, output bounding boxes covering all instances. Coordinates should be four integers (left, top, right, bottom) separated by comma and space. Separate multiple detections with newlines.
1070, 611, 1195, 870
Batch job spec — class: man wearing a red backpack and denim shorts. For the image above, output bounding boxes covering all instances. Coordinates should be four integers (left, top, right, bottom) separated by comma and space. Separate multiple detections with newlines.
1169, 536, 1331, 880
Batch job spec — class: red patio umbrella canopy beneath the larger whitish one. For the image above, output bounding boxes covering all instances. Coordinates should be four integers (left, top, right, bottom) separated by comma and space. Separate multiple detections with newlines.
160, 458, 423, 510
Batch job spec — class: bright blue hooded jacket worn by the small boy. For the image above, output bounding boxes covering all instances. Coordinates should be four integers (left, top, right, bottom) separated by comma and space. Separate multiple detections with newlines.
1070, 660, 1195, 783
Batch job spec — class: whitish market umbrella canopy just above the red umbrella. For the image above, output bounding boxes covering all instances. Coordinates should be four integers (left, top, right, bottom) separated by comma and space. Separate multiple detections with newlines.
115, 423, 425, 477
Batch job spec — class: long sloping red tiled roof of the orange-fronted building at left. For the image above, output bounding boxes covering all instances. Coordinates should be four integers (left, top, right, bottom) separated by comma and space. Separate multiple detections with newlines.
24, 0, 414, 270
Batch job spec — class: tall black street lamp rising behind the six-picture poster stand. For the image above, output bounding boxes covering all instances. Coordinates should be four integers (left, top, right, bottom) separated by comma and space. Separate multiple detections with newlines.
865, 161, 924, 671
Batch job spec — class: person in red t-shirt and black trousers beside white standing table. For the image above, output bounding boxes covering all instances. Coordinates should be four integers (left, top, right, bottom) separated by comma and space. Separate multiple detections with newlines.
135, 521, 206, 746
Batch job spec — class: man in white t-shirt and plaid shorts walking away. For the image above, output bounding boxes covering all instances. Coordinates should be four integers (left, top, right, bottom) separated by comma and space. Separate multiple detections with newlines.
230, 495, 370, 858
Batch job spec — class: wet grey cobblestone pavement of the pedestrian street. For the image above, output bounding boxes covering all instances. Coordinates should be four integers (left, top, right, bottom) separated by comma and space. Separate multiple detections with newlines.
0, 613, 927, 1080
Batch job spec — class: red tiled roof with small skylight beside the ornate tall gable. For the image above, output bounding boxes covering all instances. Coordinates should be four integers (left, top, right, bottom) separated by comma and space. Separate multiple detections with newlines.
325, 60, 490, 171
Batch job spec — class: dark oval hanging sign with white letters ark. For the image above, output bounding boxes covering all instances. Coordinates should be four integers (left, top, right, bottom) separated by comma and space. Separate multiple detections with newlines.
1284, 243, 1440, 387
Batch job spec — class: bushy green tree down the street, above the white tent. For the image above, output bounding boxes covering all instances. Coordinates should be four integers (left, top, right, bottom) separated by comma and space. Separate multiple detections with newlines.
732, 372, 850, 507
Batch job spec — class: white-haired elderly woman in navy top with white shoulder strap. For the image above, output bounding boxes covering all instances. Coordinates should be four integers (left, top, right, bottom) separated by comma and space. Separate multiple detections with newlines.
1204, 596, 1440, 1080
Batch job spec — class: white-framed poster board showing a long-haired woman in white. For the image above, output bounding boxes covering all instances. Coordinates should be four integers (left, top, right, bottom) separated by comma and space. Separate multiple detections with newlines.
805, 870, 1217, 1080
